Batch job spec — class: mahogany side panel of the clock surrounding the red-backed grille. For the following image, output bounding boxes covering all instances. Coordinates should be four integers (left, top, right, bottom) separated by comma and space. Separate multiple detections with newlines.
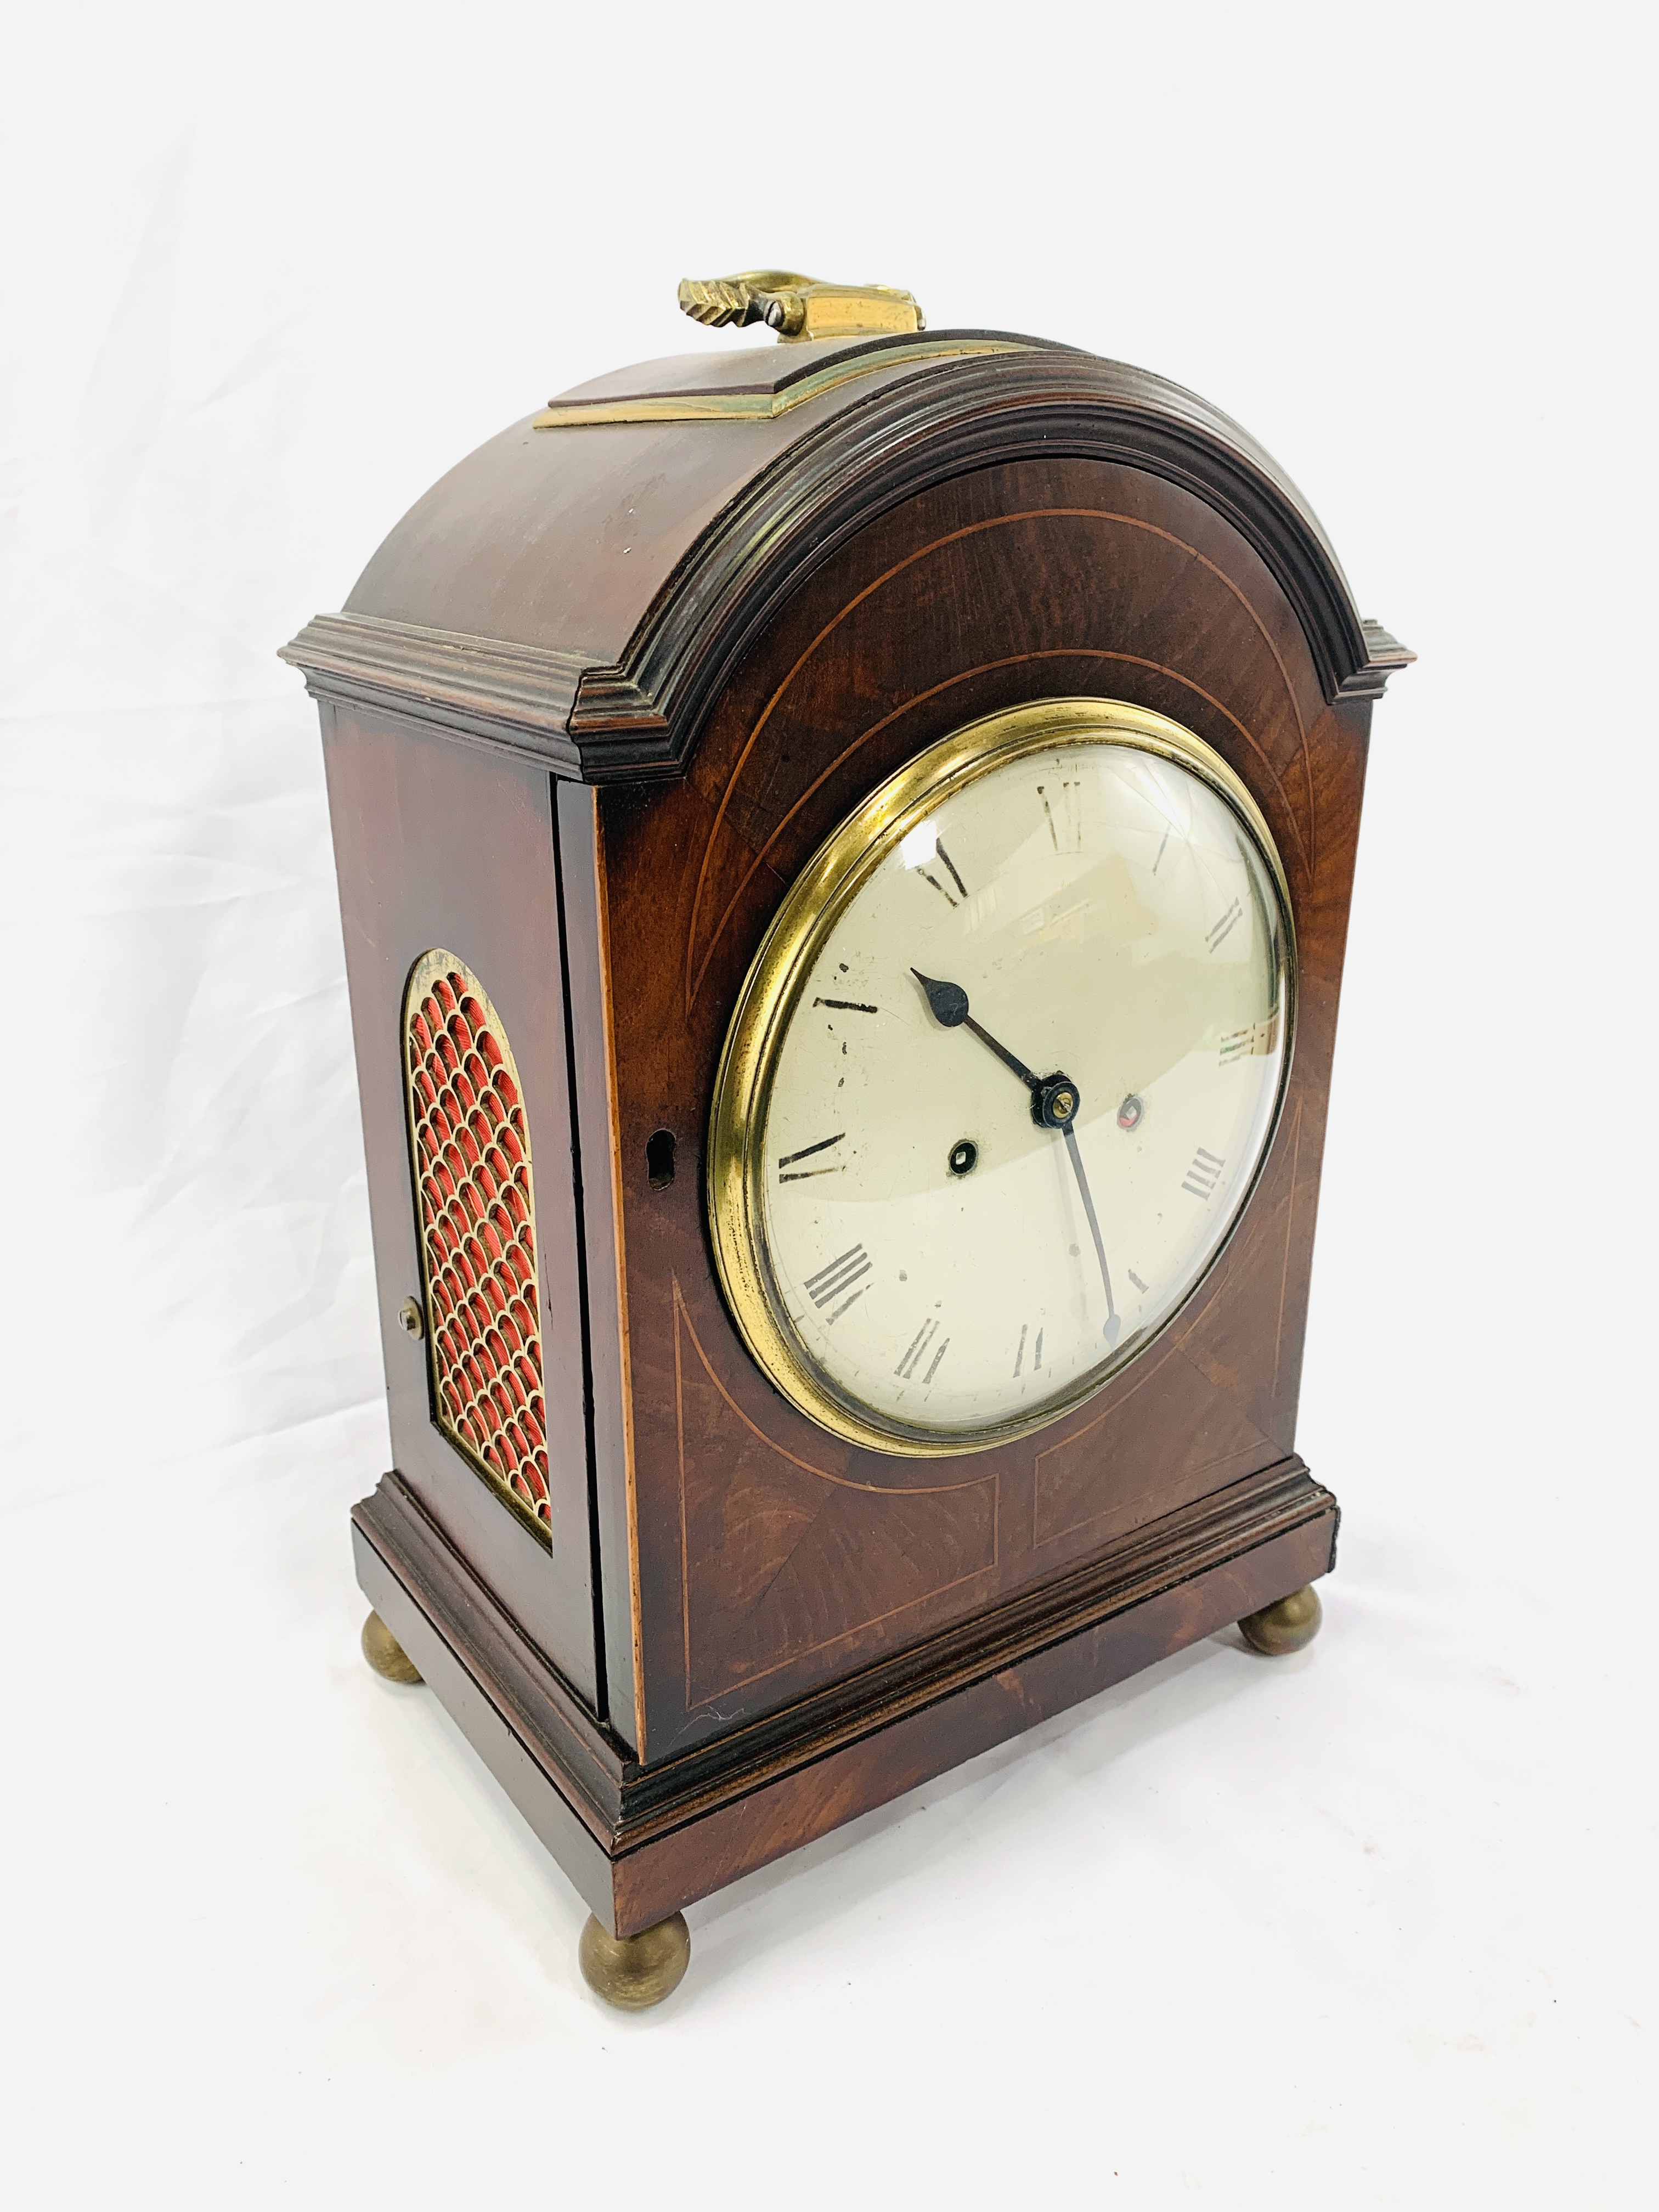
323, 706, 600, 1706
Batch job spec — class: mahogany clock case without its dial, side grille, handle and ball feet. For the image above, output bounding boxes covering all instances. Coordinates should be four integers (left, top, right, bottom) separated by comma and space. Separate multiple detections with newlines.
287, 334, 1409, 1936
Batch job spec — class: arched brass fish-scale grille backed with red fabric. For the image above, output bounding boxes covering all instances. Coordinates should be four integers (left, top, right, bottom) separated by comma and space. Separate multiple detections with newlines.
405, 951, 551, 1542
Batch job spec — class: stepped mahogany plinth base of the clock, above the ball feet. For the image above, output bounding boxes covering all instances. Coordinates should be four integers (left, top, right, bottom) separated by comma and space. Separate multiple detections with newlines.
354, 1458, 1336, 1946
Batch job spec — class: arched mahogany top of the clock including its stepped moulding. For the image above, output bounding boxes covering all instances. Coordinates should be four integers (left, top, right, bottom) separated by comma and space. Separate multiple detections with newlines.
283, 330, 1413, 783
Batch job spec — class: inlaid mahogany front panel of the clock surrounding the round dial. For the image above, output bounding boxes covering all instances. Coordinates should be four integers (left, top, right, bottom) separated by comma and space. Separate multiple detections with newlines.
600, 460, 1369, 1758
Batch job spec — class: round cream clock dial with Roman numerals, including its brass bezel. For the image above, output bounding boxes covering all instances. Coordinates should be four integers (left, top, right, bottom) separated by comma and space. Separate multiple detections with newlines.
710, 701, 1292, 1453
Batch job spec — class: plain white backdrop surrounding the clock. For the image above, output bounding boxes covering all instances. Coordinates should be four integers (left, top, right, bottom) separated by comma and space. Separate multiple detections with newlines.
0, 0, 1659, 2208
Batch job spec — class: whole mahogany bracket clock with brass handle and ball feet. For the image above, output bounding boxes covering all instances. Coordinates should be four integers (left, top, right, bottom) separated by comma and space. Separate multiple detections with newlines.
285, 270, 1411, 2006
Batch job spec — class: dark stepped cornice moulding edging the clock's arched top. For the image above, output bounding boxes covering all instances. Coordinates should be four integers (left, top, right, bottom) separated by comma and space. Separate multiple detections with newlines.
281, 349, 1413, 783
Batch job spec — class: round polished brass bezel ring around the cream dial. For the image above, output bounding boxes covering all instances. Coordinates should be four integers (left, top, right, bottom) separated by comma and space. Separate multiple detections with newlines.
706, 699, 1296, 1460
